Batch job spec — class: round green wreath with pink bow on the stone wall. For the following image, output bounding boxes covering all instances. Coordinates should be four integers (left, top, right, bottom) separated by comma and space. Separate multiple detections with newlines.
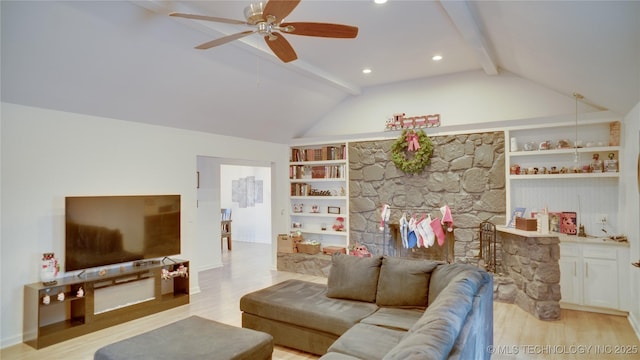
391, 130, 433, 174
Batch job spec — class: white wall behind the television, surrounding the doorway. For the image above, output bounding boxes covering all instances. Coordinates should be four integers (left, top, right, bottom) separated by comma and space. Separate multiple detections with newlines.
0, 103, 289, 347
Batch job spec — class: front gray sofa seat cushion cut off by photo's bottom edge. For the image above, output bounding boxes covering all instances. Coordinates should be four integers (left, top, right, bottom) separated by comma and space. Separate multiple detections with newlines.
329, 323, 406, 360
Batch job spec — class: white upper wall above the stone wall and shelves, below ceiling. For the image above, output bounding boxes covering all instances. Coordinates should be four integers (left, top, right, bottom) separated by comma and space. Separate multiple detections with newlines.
304, 71, 594, 138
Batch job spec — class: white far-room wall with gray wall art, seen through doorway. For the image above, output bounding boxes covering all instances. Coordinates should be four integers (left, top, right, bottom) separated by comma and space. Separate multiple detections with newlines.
220, 165, 272, 244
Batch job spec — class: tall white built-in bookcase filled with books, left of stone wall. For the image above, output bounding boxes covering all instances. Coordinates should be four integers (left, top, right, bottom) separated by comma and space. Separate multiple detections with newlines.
289, 143, 349, 247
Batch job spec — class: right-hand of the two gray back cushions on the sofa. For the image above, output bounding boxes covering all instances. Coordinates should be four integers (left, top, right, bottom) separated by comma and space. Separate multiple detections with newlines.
376, 256, 442, 308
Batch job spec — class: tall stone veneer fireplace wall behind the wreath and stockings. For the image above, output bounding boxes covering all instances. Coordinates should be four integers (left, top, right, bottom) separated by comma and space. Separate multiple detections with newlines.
349, 132, 506, 264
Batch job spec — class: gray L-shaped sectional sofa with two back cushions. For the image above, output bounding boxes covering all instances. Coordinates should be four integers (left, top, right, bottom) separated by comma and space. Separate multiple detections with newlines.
240, 254, 493, 360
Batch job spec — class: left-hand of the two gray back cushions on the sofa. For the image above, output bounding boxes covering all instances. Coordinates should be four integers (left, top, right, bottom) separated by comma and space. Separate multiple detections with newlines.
327, 253, 382, 302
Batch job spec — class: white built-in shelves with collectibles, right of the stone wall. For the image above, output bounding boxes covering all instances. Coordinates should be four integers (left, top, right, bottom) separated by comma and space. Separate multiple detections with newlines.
505, 117, 625, 236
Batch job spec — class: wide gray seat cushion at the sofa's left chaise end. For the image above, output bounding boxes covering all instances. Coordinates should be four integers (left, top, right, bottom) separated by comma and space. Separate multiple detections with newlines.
240, 279, 378, 336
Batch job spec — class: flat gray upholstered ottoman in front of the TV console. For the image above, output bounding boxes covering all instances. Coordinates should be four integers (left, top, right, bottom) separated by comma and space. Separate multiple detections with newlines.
93, 316, 273, 360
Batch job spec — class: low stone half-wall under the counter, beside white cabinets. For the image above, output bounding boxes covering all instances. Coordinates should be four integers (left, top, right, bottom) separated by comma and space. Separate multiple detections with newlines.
496, 232, 561, 320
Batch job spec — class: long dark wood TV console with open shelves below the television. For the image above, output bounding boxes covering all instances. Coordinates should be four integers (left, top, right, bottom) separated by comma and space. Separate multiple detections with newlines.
23, 260, 189, 349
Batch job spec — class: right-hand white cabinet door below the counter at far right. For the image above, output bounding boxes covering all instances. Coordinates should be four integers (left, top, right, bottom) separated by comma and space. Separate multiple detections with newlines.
583, 258, 619, 309
